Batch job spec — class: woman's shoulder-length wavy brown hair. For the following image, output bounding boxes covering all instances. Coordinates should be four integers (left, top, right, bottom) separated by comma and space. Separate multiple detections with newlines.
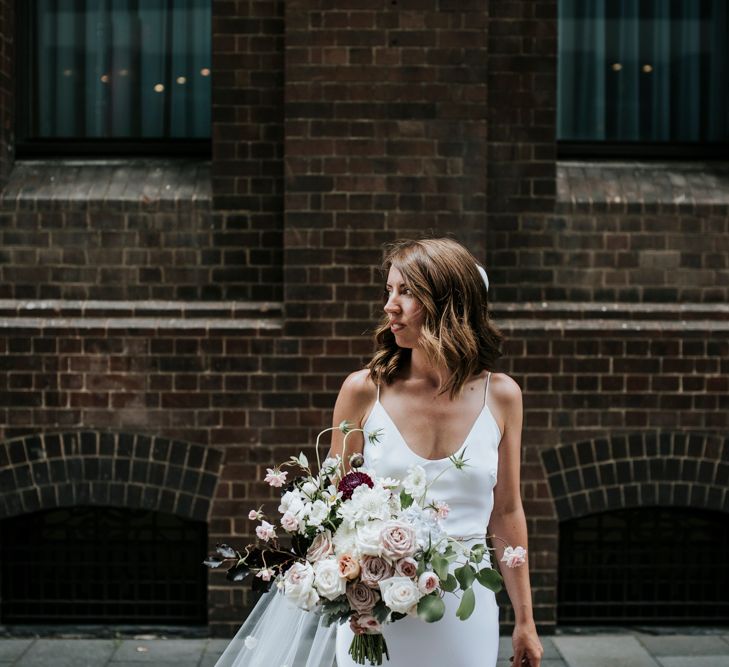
367, 238, 504, 399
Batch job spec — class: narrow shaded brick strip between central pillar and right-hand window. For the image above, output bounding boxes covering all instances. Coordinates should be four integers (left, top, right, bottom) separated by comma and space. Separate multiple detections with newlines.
487, 0, 559, 302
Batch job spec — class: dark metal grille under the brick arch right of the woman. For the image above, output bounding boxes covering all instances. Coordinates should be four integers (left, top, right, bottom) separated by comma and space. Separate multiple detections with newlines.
557, 507, 729, 625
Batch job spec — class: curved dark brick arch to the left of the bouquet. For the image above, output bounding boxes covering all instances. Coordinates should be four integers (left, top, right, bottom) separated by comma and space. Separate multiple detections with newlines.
0, 431, 223, 521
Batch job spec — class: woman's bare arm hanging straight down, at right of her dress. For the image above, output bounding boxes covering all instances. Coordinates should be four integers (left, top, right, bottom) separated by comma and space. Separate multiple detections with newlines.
489, 375, 543, 667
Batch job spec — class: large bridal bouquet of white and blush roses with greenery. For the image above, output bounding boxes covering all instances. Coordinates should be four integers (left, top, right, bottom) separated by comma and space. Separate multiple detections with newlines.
205, 422, 526, 665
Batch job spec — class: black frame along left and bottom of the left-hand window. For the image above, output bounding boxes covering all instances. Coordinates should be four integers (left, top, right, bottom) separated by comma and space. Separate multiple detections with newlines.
14, 0, 212, 159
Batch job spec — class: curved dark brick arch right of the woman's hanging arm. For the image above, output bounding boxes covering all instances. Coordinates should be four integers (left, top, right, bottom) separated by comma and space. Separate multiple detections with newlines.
541, 431, 729, 521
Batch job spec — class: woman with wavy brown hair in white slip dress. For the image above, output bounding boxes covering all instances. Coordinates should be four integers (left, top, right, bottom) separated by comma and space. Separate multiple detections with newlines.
331, 238, 543, 667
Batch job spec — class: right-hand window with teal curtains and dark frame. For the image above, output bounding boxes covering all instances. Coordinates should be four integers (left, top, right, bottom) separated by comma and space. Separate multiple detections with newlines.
557, 0, 729, 156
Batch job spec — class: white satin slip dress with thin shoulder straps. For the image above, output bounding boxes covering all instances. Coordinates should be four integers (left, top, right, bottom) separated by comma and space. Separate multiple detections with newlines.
336, 372, 502, 667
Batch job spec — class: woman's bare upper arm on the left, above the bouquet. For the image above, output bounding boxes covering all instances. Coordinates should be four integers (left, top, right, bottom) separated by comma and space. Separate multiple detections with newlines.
328, 368, 377, 471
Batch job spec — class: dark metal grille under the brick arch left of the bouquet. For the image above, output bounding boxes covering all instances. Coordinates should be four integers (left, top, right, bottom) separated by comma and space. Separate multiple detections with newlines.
0, 507, 207, 625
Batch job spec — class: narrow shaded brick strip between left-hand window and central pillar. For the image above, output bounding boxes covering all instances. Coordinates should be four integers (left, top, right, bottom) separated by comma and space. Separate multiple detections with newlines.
212, 0, 284, 300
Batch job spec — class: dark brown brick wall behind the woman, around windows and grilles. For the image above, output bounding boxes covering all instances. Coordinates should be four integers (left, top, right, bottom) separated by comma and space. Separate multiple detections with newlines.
0, 0, 729, 636
